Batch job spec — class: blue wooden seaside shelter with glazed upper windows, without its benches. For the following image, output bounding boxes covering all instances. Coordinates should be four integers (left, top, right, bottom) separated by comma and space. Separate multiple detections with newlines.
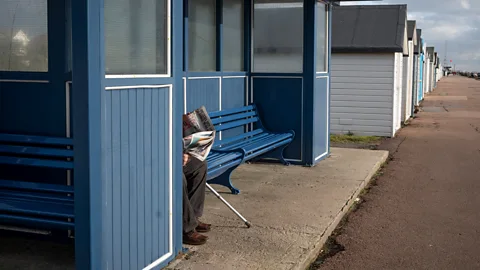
0, 0, 358, 269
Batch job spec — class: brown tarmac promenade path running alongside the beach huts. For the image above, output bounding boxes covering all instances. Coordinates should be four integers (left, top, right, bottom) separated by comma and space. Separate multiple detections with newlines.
320, 76, 480, 270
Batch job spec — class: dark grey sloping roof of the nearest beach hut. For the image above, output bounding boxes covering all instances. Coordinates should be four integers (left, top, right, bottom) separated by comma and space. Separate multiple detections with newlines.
332, 5, 407, 52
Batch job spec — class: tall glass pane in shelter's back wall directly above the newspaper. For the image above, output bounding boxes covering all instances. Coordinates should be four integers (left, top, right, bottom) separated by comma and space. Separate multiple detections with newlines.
188, 0, 217, 71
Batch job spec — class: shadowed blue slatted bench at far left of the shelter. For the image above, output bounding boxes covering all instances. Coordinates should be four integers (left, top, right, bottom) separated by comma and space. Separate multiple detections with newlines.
0, 134, 75, 230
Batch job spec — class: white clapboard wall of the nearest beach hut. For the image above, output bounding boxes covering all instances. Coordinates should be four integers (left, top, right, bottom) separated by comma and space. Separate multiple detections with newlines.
330, 53, 402, 137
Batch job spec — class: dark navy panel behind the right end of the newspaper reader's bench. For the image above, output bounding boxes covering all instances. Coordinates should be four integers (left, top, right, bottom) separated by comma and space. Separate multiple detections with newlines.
252, 77, 303, 160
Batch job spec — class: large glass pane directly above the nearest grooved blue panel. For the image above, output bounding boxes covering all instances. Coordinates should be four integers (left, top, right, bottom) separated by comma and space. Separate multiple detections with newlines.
104, 0, 169, 75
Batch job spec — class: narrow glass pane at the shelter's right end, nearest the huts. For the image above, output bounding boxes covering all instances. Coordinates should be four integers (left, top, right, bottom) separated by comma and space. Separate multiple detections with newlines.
316, 2, 328, 72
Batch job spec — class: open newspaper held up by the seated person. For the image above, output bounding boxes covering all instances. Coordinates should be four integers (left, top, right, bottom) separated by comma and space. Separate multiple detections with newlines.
183, 106, 215, 161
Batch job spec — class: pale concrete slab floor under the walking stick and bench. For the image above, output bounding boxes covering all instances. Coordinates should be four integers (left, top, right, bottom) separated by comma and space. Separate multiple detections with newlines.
168, 148, 388, 270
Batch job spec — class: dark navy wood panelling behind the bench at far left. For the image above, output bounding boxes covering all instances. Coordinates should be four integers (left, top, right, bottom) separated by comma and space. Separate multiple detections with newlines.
0, 82, 67, 185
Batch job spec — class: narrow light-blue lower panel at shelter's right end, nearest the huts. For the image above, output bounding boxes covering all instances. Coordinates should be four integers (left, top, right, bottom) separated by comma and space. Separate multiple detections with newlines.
313, 77, 329, 162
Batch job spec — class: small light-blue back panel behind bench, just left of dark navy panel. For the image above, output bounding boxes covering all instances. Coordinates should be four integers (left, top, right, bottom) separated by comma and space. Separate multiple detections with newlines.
222, 77, 246, 139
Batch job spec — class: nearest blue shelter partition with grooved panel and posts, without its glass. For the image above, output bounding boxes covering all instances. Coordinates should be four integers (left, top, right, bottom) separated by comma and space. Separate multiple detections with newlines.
72, 0, 183, 269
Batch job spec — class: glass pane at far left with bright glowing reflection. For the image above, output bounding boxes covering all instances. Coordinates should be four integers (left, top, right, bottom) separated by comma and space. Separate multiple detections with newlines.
0, 0, 48, 72
